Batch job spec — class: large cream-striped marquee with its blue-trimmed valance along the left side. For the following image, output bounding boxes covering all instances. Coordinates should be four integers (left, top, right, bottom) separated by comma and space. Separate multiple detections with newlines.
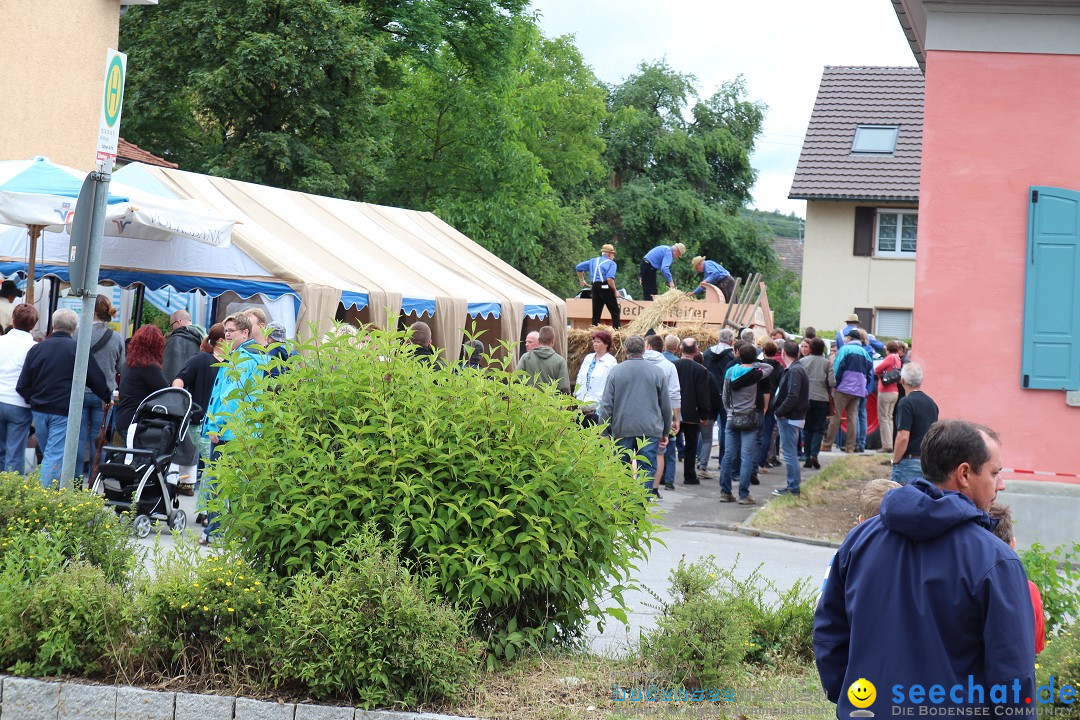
0, 163, 566, 359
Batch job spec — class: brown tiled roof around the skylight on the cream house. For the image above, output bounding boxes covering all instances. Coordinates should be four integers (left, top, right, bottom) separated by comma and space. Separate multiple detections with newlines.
788, 66, 923, 201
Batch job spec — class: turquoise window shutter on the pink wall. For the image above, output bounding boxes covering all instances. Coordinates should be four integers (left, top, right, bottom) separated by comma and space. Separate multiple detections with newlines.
1021, 187, 1080, 390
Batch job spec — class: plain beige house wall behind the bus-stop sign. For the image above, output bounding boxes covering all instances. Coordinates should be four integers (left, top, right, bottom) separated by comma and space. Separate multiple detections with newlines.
0, 0, 120, 172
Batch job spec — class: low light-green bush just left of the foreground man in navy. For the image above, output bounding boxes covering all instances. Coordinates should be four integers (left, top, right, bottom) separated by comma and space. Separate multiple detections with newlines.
642, 556, 814, 689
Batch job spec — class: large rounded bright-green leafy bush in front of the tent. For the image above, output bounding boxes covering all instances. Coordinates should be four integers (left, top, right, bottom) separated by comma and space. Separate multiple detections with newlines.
210, 331, 654, 658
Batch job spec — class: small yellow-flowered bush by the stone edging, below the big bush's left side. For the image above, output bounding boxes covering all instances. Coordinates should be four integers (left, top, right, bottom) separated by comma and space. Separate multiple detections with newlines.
138, 544, 279, 685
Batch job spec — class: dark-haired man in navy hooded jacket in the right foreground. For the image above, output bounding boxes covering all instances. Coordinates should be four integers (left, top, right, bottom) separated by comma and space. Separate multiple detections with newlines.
813, 420, 1038, 718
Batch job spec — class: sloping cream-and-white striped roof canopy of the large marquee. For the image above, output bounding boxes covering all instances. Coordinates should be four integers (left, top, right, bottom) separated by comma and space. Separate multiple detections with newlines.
103, 163, 566, 359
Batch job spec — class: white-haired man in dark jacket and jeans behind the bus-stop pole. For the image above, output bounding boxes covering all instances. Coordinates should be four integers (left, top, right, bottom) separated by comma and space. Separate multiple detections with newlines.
15, 308, 112, 488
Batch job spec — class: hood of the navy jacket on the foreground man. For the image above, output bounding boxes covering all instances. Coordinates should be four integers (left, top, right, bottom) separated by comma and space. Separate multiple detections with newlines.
881, 478, 990, 541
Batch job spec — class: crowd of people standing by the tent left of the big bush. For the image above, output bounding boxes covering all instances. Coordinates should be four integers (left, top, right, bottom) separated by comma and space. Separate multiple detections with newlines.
0, 297, 288, 511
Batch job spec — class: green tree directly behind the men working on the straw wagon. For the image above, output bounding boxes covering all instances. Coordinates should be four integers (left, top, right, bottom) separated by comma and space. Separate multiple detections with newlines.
594, 62, 775, 288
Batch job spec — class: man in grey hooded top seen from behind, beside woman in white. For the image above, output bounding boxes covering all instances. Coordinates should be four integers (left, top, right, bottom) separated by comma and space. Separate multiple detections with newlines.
596, 335, 672, 498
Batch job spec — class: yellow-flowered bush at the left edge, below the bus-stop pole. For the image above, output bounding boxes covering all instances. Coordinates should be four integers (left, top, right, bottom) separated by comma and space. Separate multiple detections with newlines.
0, 473, 137, 583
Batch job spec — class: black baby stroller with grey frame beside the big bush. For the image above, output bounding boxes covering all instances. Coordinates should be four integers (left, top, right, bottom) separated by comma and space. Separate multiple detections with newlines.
91, 388, 193, 538
